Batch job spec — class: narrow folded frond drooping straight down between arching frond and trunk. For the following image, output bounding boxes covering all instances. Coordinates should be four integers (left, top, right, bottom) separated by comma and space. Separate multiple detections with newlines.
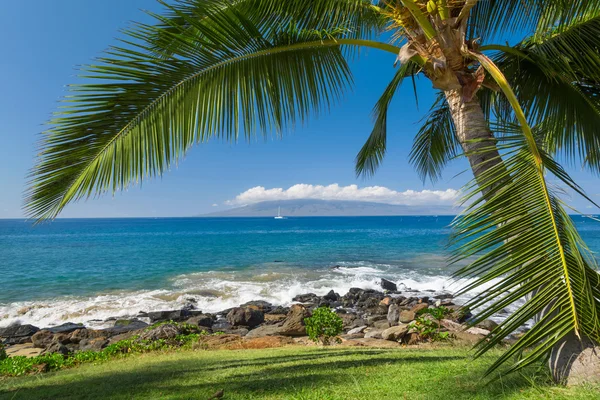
356, 61, 419, 176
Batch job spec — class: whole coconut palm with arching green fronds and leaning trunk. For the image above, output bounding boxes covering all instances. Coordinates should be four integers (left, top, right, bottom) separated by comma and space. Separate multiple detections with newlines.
26, 0, 600, 379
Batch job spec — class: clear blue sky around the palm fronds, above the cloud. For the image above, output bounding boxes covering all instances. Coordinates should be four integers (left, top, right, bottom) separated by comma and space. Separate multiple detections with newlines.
0, 0, 600, 218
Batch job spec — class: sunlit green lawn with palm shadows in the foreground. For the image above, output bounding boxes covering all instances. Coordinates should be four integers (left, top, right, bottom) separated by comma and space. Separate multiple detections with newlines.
0, 347, 600, 400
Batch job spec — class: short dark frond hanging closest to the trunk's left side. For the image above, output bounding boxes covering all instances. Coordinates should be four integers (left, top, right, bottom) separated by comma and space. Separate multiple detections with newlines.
409, 93, 460, 183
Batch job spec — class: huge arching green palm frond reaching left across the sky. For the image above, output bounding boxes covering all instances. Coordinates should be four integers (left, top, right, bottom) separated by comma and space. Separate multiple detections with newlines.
26, 0, 398, 219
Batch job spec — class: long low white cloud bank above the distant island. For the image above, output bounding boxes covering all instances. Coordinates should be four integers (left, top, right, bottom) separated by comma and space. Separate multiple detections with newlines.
225, 183, 459, 206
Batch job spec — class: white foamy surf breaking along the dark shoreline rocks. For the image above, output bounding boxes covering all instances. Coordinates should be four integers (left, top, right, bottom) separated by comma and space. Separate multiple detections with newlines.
0, 262, 516, 328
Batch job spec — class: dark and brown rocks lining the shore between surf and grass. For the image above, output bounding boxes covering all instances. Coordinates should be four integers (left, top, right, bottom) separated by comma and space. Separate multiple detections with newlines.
0, 279, 496, 356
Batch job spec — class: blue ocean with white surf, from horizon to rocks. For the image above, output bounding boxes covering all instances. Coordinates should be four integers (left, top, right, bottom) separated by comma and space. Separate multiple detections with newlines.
0, 216, 600, 327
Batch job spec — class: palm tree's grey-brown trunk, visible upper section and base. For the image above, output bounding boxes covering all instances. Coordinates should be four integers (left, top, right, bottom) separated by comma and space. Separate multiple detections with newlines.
445, 91, 600, 384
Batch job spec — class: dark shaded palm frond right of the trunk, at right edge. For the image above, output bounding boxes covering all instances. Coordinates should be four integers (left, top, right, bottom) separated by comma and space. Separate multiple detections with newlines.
484, 14, 600, 173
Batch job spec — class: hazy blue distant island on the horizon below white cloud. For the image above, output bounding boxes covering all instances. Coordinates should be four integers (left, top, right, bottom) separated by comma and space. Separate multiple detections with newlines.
199, 200, 460, 217
